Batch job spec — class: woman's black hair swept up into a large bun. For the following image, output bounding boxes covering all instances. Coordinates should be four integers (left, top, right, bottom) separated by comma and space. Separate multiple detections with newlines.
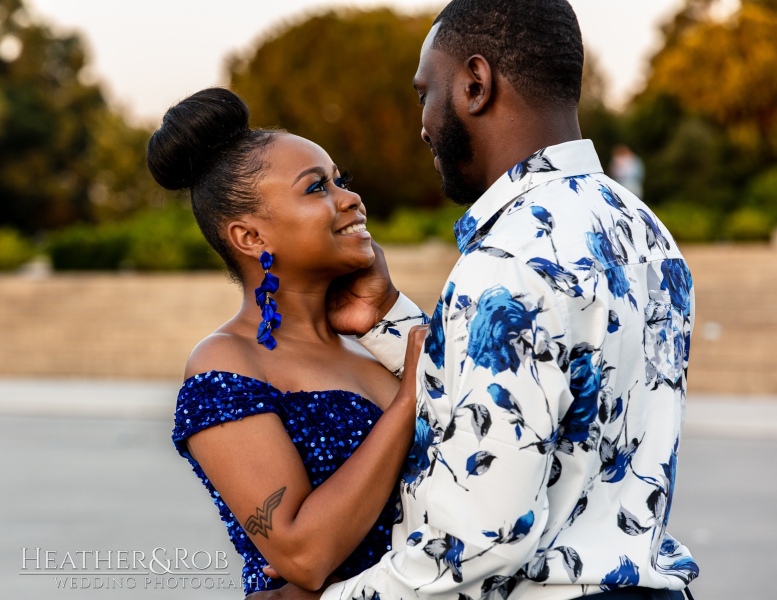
147, 88, 280, 281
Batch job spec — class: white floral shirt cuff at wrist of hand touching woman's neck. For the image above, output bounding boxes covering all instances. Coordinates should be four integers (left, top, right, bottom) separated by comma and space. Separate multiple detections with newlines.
357, 292, 429, 377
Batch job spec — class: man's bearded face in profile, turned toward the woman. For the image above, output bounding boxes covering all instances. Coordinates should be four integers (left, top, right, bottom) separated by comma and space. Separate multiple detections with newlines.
413, 24, 483, 205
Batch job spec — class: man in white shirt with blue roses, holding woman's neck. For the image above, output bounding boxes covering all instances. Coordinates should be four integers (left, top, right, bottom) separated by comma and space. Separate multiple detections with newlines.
255, 0, 698, 600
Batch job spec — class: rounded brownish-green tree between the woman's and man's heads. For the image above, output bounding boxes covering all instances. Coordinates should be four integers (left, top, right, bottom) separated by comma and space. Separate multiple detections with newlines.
231, 9, 442, 217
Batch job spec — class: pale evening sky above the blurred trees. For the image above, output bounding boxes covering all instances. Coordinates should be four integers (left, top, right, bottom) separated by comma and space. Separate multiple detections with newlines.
27, 0, 737, 126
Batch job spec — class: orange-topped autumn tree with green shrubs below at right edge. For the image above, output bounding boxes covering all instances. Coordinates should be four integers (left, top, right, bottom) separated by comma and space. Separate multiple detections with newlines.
624, 0, 777, 241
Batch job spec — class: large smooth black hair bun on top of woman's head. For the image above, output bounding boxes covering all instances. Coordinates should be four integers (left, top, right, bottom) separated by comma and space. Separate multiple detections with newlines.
147, 88, 249, 190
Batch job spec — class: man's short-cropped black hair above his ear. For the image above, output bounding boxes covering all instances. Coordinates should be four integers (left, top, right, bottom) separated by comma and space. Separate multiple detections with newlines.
434, 0, 583, 105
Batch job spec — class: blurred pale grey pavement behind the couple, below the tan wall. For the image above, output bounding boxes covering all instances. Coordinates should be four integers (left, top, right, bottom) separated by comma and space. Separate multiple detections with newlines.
0, 379, 777, 600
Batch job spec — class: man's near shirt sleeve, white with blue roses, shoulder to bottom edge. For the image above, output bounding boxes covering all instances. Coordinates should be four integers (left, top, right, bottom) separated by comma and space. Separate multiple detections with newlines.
323, 251, 571, 600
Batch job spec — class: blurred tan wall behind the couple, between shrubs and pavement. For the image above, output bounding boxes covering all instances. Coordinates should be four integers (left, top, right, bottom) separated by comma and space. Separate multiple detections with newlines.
0, 244, 777, 394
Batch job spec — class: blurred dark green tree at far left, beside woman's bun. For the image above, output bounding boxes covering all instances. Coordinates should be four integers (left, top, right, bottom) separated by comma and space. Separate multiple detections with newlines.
0, 0, 164, 233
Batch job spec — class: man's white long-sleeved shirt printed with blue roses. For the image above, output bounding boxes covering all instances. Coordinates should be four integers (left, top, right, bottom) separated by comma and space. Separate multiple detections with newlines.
323, 140, 698, 600
